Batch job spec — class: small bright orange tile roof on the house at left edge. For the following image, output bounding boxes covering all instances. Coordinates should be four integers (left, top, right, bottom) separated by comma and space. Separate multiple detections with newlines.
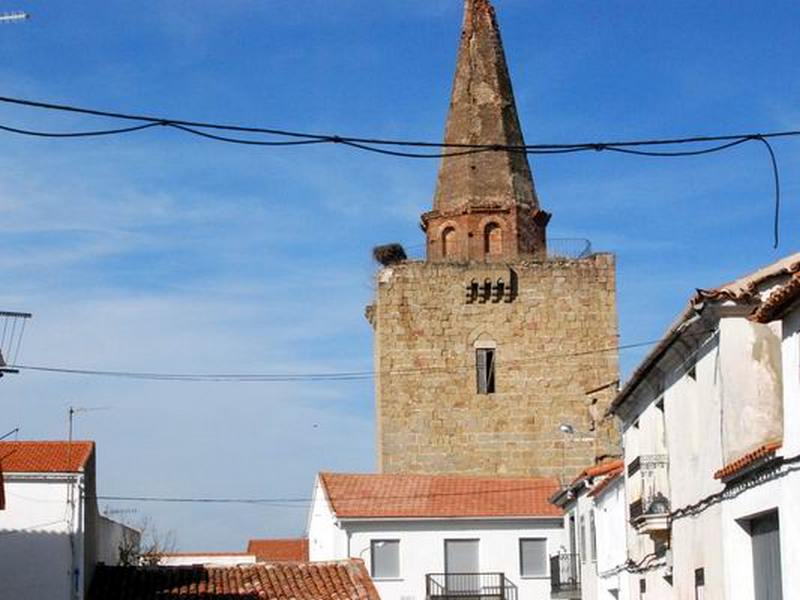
0, 441, 94, 473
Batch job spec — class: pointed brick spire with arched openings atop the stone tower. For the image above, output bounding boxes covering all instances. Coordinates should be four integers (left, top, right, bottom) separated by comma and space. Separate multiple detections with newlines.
422, 0, 550, 262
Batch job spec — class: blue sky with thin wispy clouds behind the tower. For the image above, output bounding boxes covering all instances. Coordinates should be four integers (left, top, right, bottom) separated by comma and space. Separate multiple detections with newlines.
0, 0, 800, 550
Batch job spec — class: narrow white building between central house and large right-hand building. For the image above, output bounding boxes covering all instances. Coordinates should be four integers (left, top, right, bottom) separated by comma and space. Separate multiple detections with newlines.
550, 460, 629, 600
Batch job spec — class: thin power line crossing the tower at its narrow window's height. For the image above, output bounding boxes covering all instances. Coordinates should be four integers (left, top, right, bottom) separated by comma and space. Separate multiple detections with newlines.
7, 340, 660, 383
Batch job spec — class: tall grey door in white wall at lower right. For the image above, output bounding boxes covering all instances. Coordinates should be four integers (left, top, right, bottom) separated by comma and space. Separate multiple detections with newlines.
750, 511, 783, 600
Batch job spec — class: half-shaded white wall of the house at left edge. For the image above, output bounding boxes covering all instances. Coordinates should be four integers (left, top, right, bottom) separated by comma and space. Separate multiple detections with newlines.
0, 473, 83, 600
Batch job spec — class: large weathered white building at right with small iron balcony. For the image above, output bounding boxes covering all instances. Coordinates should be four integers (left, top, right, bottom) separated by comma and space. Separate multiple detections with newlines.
611, 254, 800, 600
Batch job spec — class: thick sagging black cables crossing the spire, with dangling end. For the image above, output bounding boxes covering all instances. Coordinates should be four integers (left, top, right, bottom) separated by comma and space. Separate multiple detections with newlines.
0, 96, 800, 248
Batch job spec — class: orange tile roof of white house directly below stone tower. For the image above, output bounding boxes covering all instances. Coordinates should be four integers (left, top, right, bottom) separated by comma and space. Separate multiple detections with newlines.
320, 473, 562, 518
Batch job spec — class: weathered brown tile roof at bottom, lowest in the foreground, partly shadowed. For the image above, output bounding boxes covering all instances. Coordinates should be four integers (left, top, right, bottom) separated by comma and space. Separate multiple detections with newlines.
88, 559, 380, 600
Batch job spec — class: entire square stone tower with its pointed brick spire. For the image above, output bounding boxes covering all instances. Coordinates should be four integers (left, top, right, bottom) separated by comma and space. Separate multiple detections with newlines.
367, 0, 618, 476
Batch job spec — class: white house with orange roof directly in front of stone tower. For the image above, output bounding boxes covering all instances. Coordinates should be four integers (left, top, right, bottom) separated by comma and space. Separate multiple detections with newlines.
308, 473, 565, 600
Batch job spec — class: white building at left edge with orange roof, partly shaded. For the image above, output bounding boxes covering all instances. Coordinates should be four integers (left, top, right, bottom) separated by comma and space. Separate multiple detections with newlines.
0, 442, 138, 600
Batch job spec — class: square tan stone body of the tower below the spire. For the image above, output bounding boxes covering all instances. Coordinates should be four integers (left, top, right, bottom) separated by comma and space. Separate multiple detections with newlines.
368, 254, 619, 476
